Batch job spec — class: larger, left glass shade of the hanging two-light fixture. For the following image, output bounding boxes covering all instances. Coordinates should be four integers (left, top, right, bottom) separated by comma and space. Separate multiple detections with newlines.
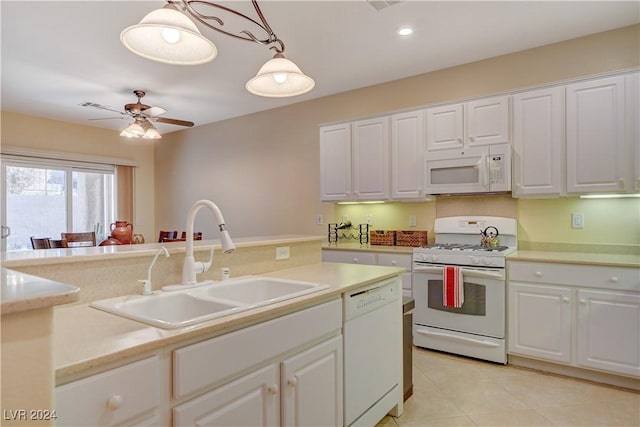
120, 5, 218, 65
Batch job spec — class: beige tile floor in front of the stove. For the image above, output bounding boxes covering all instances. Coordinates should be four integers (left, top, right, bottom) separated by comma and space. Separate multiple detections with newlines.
378, 347, 640, 427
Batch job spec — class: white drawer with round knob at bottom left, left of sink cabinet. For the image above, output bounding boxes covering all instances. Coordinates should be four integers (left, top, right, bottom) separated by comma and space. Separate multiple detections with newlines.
56, 356, 160, 426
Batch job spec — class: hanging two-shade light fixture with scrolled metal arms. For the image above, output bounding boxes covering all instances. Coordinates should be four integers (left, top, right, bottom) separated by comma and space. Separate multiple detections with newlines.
120, 0, 315, 98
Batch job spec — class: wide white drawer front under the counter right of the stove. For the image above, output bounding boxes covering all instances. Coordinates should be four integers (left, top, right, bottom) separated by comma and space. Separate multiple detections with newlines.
507, 261, 640, 292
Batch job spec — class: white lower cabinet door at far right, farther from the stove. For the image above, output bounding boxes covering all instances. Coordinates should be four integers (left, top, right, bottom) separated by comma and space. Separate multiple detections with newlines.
578, 289, 640, 377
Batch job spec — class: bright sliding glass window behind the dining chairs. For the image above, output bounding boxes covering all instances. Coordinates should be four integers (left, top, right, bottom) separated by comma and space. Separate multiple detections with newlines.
2, 156, 116, 251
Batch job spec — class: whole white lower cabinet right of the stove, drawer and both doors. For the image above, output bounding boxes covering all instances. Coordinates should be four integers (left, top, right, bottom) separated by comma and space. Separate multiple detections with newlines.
507, 261, 640, 378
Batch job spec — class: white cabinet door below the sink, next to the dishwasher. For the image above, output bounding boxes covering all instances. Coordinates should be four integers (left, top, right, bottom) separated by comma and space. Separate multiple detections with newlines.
281, 336, 342, 427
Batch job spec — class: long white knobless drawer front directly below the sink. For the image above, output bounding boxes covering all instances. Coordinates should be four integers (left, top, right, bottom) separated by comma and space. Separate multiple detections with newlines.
173, 299, 342, 398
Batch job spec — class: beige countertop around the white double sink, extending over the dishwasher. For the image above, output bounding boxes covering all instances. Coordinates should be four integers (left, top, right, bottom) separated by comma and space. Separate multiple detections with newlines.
53, 263, 405, 381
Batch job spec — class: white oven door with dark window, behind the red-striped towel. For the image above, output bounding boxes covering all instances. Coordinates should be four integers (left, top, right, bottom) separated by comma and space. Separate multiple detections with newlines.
413, 265, 505, 338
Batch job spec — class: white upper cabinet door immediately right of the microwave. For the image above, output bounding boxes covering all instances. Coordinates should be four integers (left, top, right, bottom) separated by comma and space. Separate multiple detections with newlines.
513, 87, 565, 201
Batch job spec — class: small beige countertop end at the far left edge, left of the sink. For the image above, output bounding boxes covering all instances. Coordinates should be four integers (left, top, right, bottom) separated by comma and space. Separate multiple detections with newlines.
0, 267, 79, 314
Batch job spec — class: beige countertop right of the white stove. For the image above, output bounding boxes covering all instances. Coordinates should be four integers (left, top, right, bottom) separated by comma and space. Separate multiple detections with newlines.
507, 251, 640, 268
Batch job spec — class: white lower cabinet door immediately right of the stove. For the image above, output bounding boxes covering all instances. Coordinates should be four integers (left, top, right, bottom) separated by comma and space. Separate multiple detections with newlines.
508, 283, 571, 363
